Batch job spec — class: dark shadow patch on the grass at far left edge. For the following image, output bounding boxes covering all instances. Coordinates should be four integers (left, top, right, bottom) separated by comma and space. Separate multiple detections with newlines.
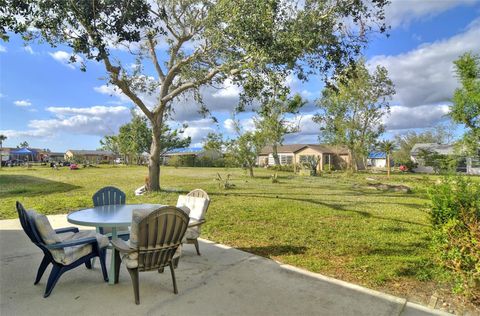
0, 175, 81, 198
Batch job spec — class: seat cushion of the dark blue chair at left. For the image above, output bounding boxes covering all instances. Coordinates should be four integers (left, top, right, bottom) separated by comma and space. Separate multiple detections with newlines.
51, 231, 109, 265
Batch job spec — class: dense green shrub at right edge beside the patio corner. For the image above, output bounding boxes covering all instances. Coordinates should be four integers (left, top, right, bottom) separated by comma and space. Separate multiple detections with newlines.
430, 177, 480, 300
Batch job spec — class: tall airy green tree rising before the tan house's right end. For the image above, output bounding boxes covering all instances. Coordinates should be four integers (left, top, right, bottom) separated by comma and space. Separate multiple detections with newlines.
314, 59, 395, 169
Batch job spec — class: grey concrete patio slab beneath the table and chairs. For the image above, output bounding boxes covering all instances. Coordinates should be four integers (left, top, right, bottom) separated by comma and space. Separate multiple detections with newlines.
0, 215, 446, 316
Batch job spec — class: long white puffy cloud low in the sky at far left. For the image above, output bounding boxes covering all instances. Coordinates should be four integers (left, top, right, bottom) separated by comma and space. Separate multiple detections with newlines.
2, 106, 130, 137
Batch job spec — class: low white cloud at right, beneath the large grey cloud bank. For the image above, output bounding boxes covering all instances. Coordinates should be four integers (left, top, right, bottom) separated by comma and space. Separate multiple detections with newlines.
383, 104, 450, 131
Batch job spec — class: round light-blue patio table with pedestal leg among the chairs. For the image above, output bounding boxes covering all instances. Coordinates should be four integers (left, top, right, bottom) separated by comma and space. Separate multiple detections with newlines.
67, 204, 164, 284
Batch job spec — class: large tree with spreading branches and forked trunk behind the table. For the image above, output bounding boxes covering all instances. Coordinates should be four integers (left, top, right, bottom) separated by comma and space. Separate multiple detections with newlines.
0, 0, 388, 190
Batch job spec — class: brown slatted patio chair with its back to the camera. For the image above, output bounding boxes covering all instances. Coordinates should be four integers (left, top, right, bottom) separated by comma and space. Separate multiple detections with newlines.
112, 206, 189, 304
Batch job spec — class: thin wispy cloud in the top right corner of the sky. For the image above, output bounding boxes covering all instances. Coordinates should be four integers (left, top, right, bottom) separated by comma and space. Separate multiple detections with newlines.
385, 0, 478, 28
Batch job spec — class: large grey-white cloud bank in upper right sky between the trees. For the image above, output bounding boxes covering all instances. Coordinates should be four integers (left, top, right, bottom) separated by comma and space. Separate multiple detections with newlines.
369, 20, 480, 107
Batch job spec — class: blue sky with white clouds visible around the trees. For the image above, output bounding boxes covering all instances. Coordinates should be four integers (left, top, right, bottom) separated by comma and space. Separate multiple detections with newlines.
0, 0, 480, 151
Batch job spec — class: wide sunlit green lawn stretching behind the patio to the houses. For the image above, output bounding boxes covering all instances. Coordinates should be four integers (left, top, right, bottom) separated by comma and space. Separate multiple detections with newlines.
0, 167, 458, 300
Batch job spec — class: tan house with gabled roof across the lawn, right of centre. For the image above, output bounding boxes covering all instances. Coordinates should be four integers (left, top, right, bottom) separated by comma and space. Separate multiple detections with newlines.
257, 144, 350, 171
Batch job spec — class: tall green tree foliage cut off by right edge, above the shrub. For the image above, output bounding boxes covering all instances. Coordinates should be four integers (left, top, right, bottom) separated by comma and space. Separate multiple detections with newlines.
450, 53, 480, 155
